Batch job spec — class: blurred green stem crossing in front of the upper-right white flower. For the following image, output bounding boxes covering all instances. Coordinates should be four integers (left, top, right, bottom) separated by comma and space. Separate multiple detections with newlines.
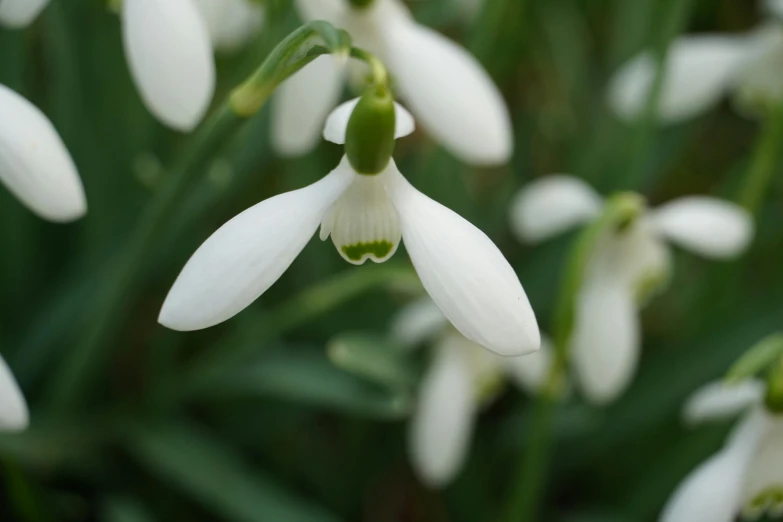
623, 0, 693, 190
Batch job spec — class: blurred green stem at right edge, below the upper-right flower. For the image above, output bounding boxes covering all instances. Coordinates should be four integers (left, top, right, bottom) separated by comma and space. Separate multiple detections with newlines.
739, 105, 783, 215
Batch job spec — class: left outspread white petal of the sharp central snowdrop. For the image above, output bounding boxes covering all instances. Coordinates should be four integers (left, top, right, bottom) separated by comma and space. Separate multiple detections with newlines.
158, 161, 355, 331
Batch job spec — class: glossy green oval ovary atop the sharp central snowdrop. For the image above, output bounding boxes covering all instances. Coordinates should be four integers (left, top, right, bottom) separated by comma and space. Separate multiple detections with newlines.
345, 85, 396, 175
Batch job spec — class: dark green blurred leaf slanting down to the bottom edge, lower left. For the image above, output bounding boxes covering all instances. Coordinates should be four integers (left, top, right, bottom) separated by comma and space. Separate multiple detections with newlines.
127, 422, 338, 522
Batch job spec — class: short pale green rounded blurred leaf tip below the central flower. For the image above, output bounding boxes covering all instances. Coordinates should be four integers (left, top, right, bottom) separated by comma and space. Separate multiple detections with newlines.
327, 332, 416, 389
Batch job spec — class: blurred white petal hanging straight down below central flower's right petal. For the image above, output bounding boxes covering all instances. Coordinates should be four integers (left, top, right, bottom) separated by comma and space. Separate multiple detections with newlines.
410, 340, 476, 487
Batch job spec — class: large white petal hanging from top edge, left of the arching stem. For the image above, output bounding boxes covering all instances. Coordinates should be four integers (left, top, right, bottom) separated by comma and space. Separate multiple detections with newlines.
122, 0, 215, 131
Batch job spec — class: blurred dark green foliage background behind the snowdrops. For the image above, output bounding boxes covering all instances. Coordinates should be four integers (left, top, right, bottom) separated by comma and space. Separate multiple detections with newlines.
0, 0, 783, 522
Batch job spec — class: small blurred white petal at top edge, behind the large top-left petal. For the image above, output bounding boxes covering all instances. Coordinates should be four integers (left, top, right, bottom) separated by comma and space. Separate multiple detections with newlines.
196, 0, 264, 52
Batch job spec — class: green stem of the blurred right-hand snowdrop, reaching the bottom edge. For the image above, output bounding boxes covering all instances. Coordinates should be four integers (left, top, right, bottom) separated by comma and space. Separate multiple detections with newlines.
505, 193, 644, 522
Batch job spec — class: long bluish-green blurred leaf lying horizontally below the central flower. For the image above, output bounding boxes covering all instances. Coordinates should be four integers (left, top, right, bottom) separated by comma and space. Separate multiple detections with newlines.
210, 349, 412, 419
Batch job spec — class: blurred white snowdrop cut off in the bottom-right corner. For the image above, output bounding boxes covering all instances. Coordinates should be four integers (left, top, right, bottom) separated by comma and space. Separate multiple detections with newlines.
661, 381, 783, 522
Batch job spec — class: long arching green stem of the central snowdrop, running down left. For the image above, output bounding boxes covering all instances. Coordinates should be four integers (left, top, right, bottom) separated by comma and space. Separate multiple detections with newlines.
47, 22, 350, 411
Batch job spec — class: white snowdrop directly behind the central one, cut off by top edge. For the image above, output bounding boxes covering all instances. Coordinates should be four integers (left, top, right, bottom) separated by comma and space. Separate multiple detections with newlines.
276, 0, 513, 165
